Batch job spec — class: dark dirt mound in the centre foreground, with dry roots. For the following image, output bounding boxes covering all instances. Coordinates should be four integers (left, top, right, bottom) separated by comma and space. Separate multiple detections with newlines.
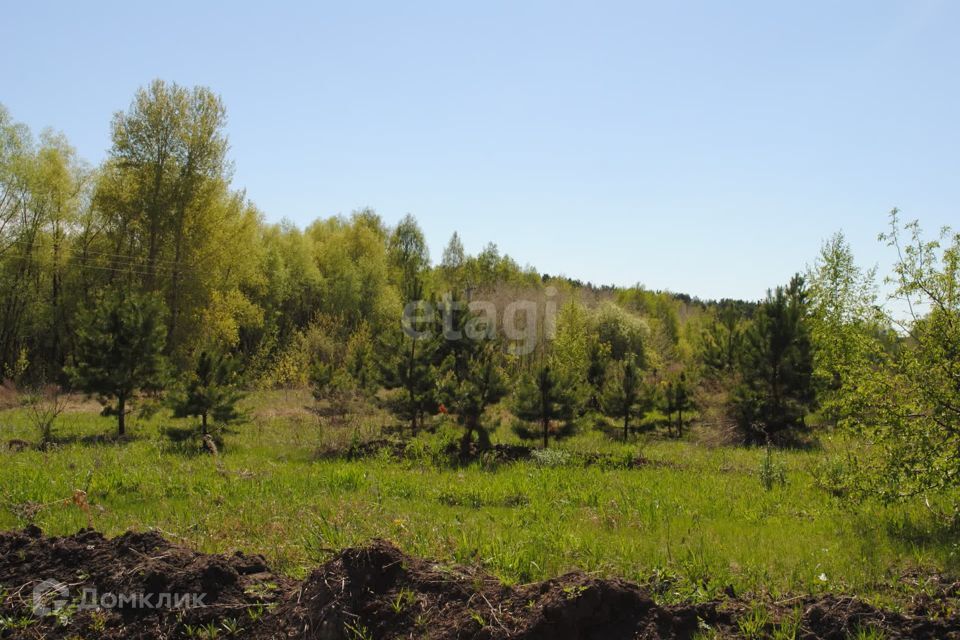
277, 541, 697, 640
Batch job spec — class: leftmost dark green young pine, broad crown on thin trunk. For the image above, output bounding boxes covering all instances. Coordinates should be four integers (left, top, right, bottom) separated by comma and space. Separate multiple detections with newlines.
67, 290, 166, 436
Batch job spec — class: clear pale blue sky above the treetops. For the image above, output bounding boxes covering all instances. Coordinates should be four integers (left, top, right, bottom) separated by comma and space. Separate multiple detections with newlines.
0, 0, 960, 299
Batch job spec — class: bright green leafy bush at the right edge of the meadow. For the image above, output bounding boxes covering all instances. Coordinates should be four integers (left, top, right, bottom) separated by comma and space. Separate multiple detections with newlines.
842, 210, 960, 500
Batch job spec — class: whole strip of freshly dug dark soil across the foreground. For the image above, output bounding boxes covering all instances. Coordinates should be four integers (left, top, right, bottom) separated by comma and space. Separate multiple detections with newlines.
0, 528, 960, 640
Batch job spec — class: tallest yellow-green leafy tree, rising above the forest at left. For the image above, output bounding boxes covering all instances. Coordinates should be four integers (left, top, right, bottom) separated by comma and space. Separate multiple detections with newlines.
96, 80, 240, 358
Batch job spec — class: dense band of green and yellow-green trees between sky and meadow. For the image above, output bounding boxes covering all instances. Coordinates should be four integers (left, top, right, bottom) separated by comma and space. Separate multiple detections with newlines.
0, 81, 960, 499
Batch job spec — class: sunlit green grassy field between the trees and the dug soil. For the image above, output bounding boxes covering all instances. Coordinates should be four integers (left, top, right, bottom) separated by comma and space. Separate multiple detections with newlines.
0, 392, 960, 606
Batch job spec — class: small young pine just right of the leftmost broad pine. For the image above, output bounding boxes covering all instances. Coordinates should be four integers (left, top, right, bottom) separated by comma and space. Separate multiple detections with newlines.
173, 351, 242, 436
